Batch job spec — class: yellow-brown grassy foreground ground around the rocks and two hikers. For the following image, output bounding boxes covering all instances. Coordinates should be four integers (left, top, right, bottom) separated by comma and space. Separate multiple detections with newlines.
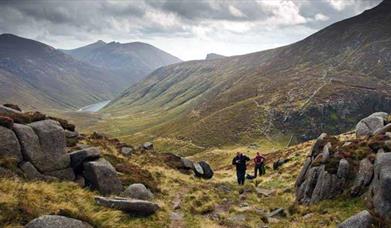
0, 133, 364, 227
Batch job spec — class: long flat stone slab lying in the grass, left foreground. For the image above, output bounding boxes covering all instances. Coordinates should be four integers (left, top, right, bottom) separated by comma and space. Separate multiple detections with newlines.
95, 196, 160, 216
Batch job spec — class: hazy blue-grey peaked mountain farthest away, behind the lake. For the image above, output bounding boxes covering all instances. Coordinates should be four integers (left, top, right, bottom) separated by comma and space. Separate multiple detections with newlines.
63, 41, 181, 85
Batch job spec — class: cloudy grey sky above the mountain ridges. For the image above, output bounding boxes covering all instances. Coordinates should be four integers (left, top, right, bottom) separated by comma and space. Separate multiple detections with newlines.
0, 0, 381, 60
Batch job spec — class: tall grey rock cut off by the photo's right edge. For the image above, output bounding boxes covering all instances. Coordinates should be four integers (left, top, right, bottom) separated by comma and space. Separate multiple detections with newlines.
369, 153, 391, 224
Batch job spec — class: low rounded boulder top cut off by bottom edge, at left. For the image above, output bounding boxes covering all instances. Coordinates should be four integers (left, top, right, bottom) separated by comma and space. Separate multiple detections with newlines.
25, 215, 92, 228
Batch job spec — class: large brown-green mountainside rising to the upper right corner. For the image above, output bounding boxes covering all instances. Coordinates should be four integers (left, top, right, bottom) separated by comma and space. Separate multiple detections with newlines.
99, 1, 391, 149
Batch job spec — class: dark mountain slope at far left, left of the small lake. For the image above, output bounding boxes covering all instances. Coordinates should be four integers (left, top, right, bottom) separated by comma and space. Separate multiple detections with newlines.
0, 34, 124, 109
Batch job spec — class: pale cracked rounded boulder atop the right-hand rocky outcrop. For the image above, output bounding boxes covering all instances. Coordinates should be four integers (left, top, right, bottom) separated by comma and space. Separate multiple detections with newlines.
356, 113, 384, 137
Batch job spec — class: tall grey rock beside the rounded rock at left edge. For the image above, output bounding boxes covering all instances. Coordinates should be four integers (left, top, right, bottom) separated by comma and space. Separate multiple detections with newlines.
29, 120, 70, 172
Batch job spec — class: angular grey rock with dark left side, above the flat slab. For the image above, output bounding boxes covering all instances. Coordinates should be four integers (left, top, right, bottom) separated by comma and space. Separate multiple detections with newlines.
83, 158, 122, 195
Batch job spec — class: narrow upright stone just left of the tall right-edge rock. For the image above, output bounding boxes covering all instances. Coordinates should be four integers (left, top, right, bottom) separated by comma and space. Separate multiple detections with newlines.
350, 158, 373, 196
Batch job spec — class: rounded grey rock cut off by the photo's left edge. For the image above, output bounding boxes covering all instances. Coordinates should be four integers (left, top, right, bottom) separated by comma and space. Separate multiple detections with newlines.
0, 126, 23, 162
